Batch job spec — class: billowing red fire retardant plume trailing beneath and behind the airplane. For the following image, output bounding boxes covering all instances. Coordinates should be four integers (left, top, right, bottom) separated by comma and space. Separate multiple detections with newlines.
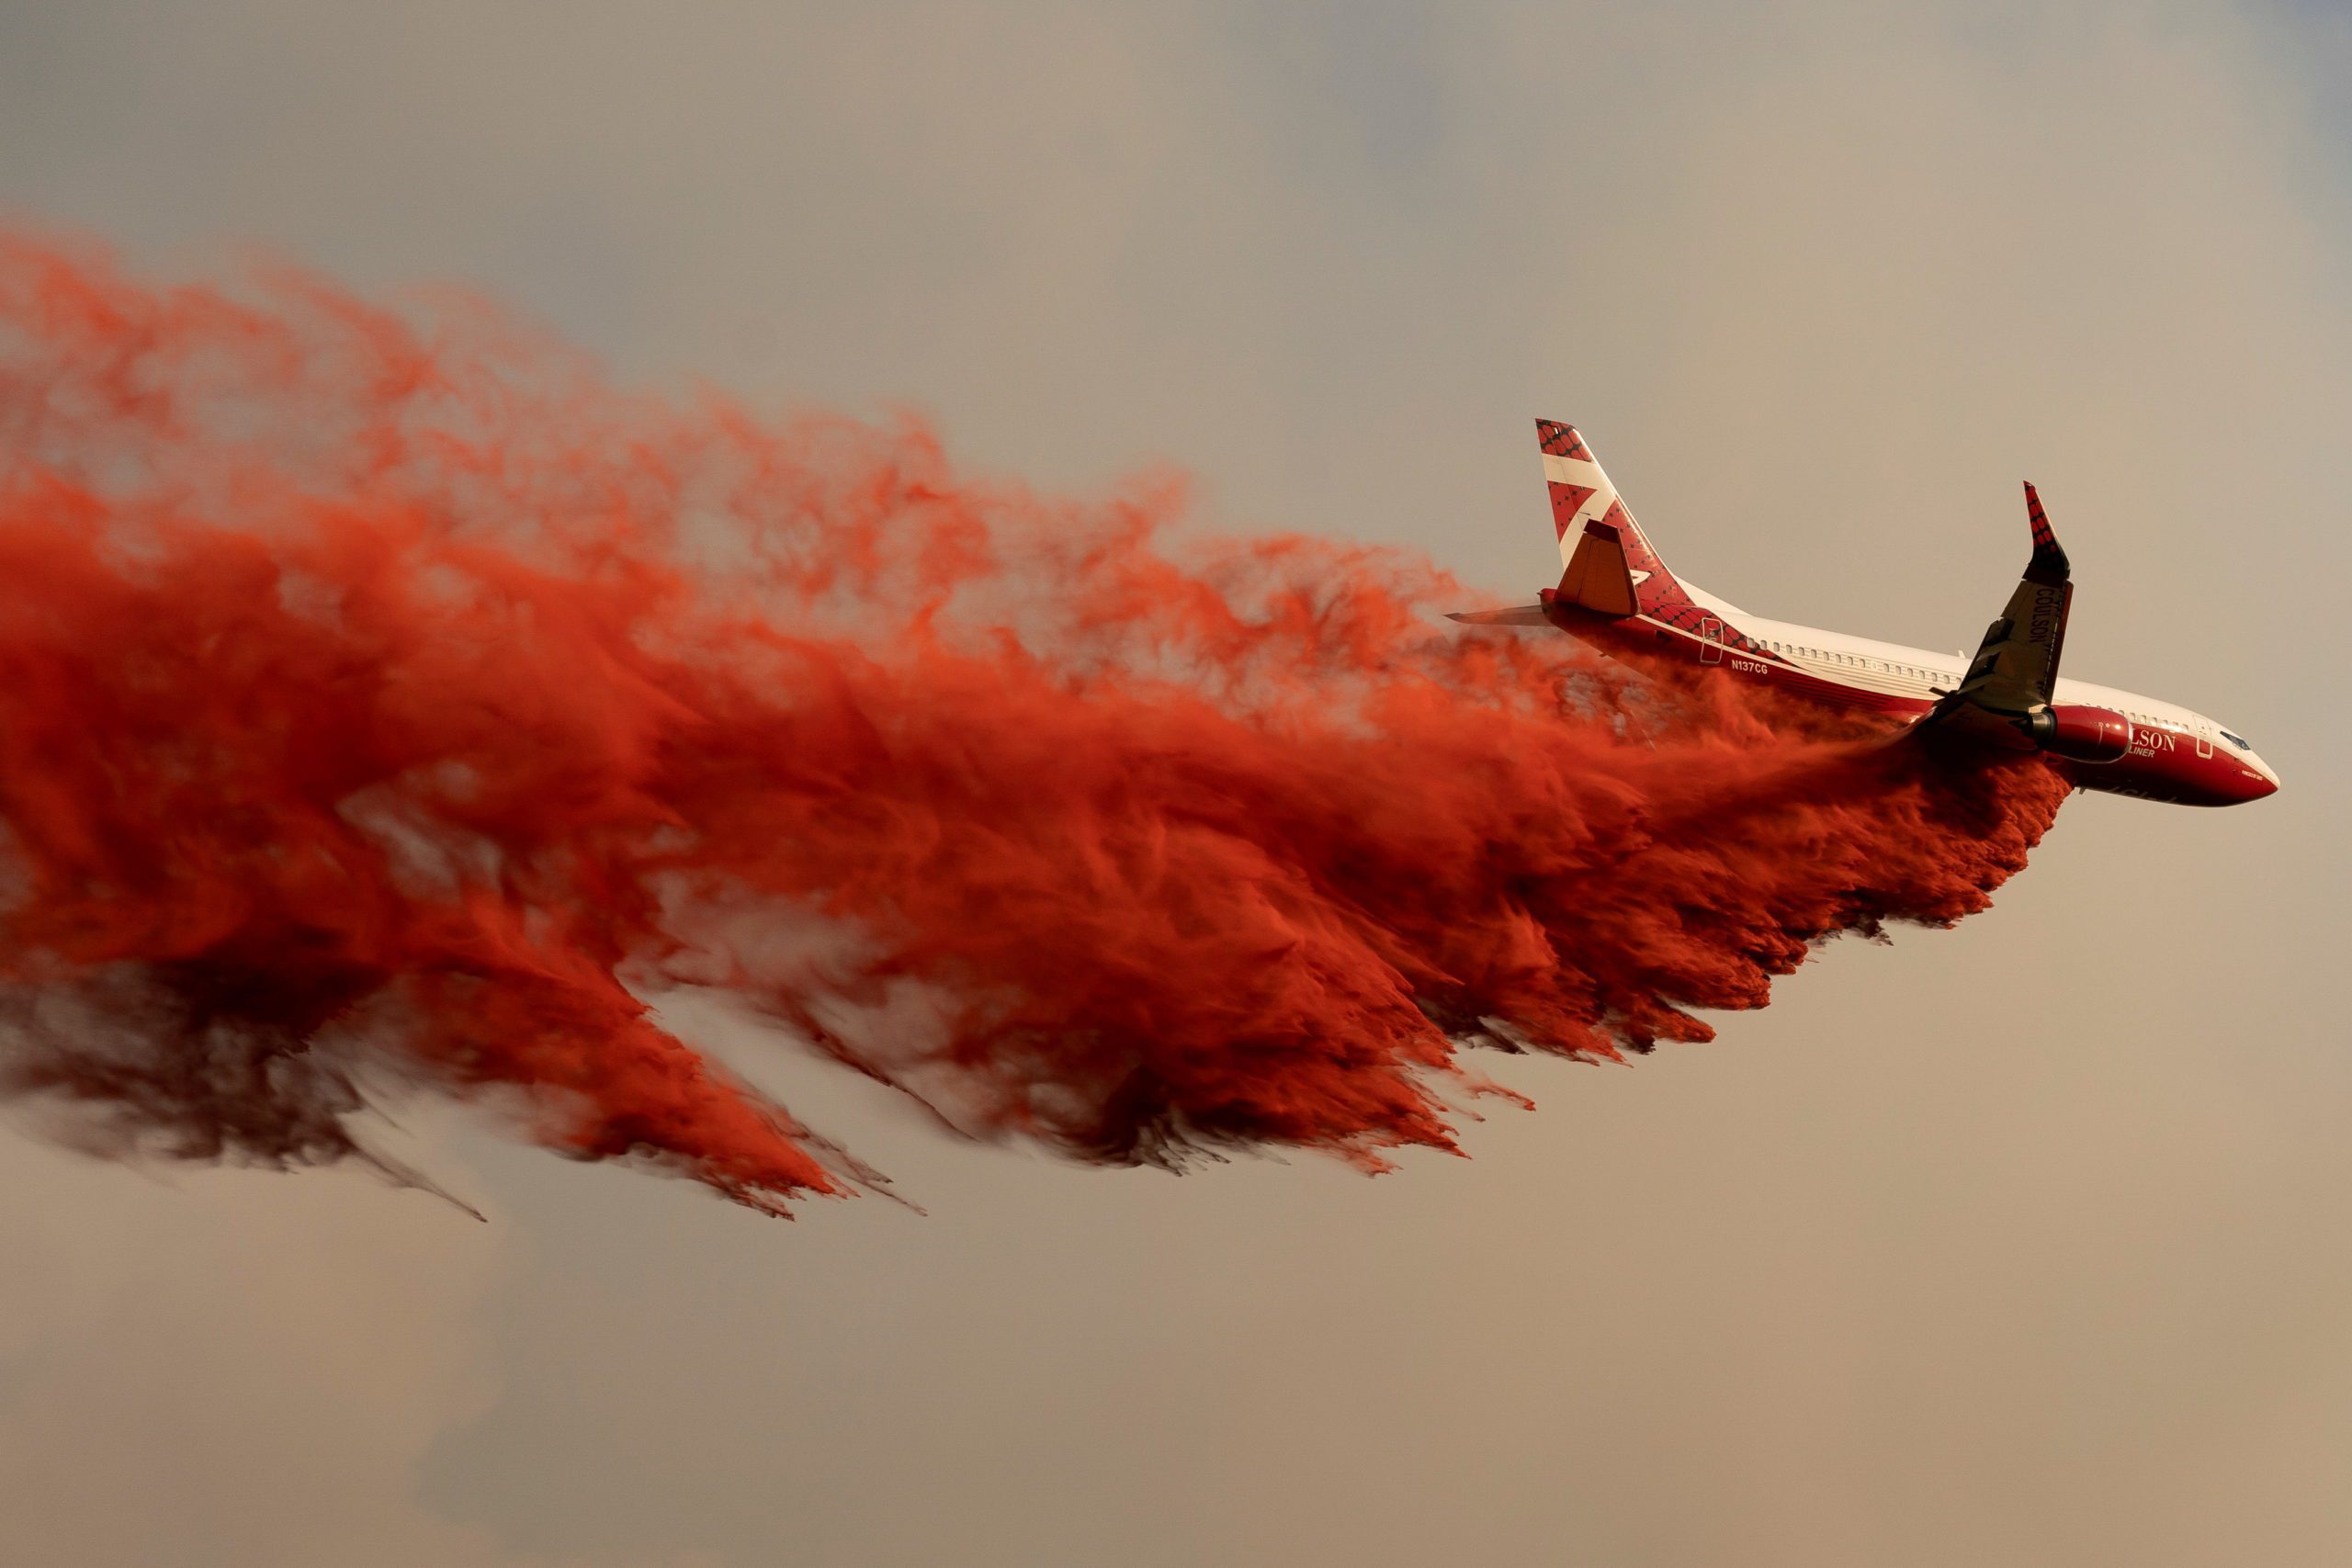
0, 237, 2065, 1211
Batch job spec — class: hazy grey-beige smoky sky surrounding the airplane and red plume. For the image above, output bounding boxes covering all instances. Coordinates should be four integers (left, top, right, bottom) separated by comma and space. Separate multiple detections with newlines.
0, 3, 2352, 1568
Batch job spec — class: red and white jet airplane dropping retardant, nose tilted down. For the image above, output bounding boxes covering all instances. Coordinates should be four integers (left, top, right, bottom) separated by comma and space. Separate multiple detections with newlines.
1453, 419, 2279, 807
